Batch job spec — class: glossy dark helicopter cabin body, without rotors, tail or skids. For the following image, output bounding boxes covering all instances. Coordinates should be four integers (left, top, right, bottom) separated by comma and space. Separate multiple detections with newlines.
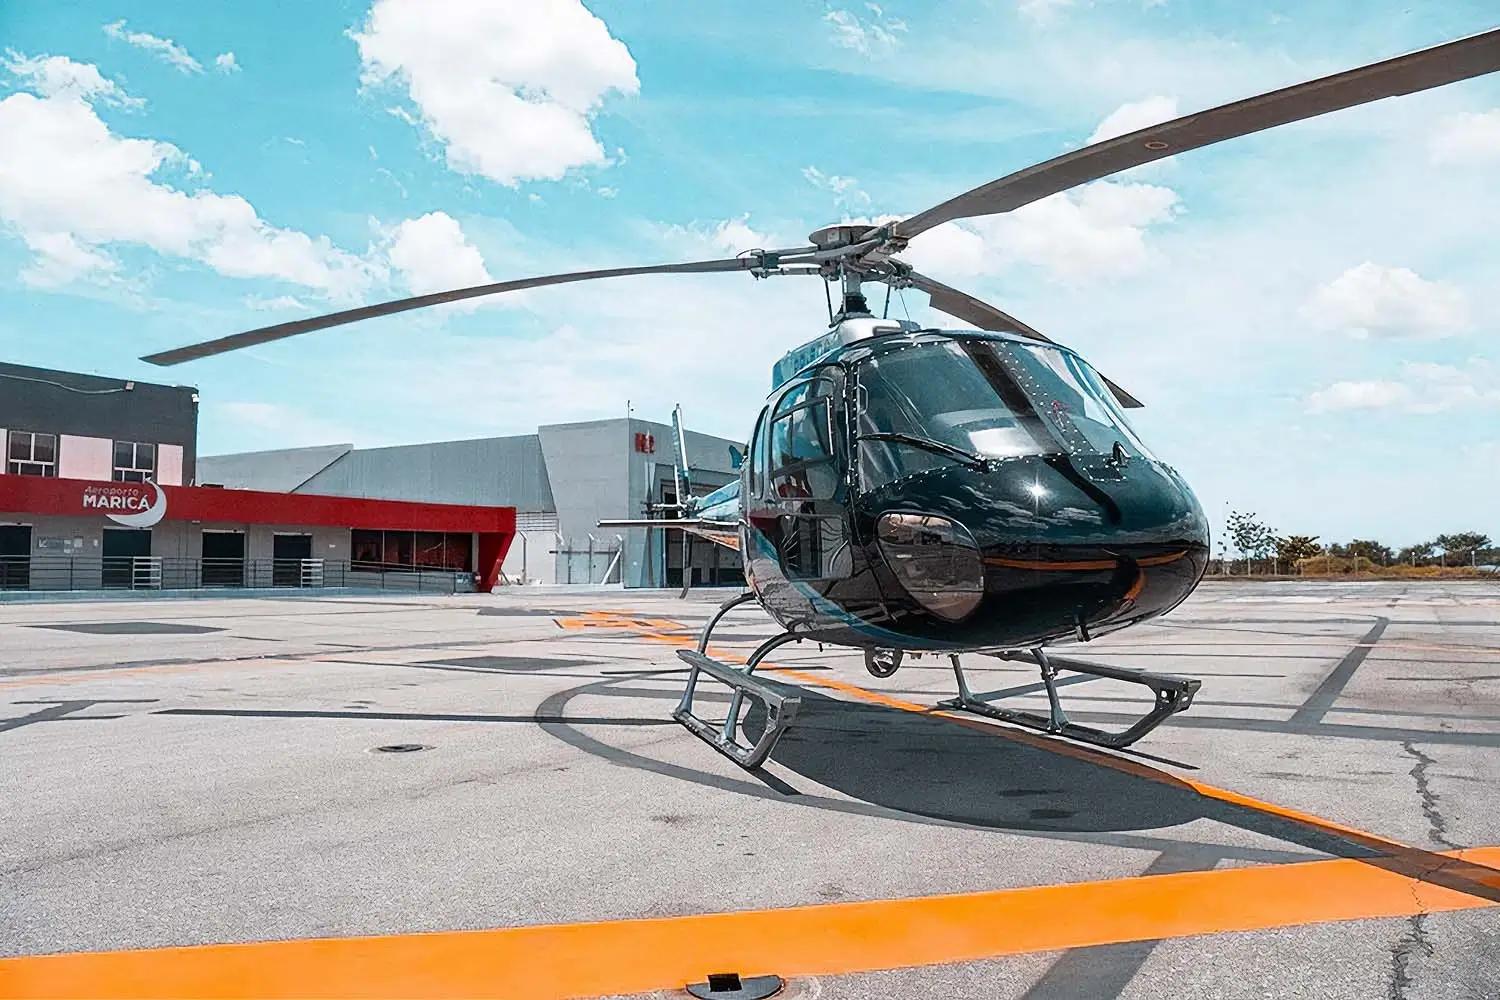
744, 331, 1209, 651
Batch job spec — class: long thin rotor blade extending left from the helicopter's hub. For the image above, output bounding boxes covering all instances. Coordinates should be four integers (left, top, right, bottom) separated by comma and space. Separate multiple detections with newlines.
141, 257, 780, 366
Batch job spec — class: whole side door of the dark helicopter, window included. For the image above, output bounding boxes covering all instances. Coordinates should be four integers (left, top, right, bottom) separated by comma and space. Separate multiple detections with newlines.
765, 370, 852, 582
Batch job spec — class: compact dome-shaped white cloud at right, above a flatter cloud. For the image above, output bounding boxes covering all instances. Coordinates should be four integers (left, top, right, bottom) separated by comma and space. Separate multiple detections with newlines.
1302, 261, 1469, 337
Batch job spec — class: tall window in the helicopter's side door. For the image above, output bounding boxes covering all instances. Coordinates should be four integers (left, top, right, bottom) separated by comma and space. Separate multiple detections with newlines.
758, 378, 839, 499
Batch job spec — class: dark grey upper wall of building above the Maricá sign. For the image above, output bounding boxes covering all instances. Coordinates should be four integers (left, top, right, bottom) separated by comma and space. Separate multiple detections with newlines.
0, 363, 198, 480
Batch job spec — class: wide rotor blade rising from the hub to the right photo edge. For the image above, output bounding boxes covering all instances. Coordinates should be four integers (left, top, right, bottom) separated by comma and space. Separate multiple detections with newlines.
891, 28, 1500, 240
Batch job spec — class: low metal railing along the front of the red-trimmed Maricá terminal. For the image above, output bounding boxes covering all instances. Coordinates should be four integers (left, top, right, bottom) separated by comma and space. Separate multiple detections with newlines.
0, 556, 474, 594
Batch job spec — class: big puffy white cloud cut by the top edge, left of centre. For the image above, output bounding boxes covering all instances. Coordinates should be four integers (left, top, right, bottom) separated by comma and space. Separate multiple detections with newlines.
353, 0, 641, 186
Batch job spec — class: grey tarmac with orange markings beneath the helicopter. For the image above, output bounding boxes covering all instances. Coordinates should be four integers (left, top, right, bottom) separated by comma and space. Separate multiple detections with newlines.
0, 582, 1500, 1000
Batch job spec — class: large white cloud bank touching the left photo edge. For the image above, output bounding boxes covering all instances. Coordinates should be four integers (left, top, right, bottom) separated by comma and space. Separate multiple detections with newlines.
0, 57, 374, 298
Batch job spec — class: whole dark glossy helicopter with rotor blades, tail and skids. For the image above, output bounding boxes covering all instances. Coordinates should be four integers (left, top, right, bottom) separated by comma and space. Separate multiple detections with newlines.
143, 28, 1500, 769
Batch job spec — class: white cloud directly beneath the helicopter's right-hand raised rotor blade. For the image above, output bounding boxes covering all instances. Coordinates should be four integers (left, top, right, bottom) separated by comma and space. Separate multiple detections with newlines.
909, 181, 1179, 282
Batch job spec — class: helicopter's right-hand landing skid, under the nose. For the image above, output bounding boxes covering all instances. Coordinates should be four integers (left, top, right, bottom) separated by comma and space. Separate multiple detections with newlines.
938, 649, 1203, 750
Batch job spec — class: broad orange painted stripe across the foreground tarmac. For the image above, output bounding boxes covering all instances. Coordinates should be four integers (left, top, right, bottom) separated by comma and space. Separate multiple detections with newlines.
0, 847, 1500, 1000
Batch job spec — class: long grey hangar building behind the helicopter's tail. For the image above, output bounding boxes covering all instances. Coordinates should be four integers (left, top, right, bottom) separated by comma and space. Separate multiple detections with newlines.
198, 417, 744, 588
